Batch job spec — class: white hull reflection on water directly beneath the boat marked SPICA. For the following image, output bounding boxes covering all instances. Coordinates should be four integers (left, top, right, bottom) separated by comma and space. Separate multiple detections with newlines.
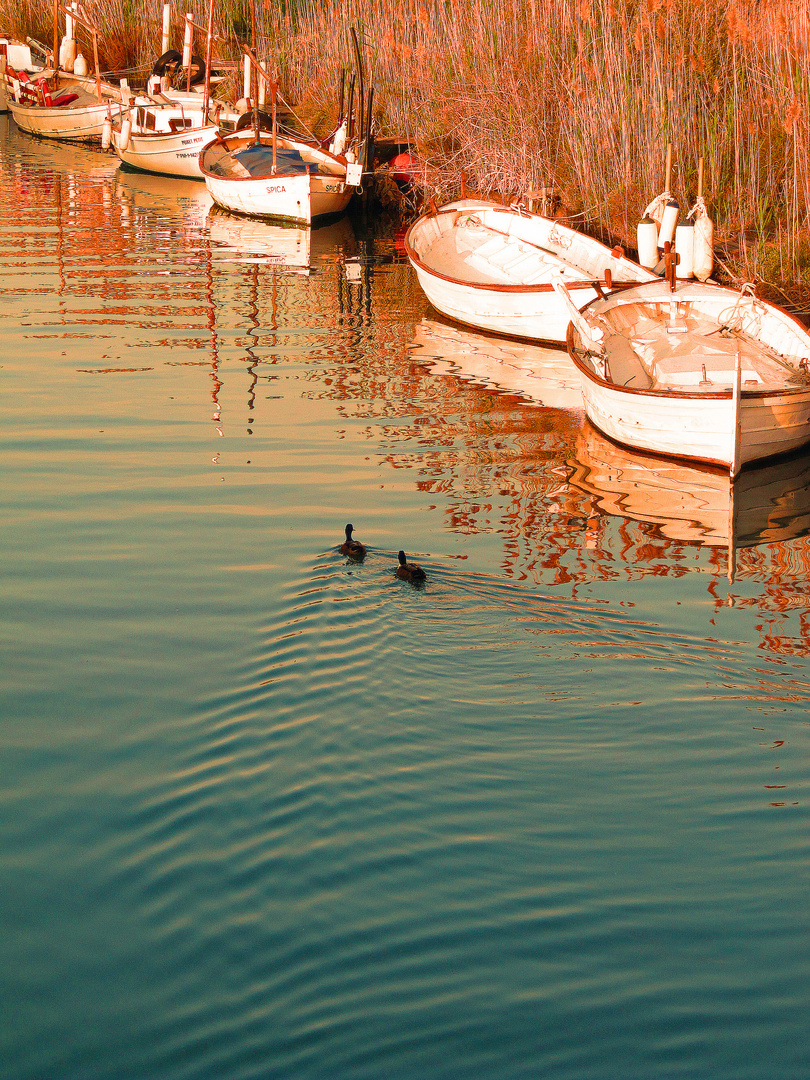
207, 206, 356, 273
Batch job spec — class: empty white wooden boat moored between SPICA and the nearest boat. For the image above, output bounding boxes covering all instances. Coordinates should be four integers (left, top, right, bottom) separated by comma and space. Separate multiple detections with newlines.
405, 199, 658, 343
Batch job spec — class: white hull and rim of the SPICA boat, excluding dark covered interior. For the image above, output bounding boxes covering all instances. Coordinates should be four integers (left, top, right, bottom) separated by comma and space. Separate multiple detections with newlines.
200, 131, 355, 225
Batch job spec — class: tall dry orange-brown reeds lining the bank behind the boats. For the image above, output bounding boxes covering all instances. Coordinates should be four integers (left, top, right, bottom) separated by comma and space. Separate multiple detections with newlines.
0, 0, 810, 297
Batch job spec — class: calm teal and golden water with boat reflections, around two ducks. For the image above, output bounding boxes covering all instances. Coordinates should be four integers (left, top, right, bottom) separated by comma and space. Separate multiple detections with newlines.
0, 119, 810, 1080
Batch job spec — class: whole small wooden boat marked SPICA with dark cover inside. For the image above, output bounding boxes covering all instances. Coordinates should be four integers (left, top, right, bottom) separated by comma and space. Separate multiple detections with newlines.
200, 129, 360, 225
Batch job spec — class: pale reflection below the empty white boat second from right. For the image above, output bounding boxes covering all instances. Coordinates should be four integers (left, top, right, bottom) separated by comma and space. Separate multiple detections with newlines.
411, 319, 584, 415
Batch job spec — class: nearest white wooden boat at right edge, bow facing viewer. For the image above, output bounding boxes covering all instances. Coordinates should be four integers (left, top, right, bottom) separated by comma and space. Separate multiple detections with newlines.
557, 281, 810, 476
